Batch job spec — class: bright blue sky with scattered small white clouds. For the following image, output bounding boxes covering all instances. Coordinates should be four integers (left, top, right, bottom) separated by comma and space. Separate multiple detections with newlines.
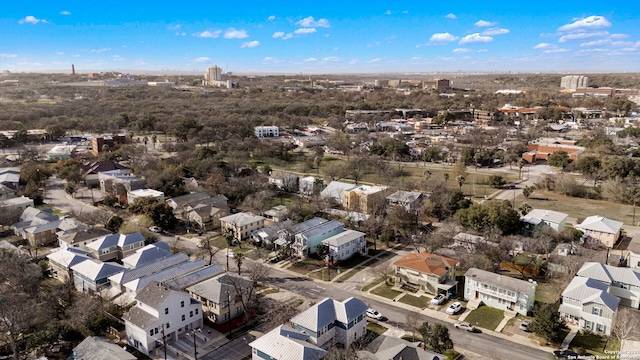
0, 0, 640, 73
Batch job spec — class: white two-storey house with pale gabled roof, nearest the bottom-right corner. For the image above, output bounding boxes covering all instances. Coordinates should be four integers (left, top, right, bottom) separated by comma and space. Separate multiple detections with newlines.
558, 276, 620, 336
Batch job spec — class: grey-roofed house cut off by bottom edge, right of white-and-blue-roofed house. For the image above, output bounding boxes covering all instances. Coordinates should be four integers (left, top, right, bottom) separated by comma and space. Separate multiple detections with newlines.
358, 335, 447, 360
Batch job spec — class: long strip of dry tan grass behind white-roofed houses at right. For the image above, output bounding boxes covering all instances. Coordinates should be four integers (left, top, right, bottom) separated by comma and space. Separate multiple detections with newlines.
516, 190, 640, 225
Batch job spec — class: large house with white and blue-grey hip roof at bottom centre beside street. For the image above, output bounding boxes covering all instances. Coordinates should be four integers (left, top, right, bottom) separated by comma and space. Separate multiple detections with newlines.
290, 297, 368, 349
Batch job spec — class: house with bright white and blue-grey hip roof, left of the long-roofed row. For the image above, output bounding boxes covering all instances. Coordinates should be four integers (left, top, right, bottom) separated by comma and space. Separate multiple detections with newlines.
71, 259, 125, 292
